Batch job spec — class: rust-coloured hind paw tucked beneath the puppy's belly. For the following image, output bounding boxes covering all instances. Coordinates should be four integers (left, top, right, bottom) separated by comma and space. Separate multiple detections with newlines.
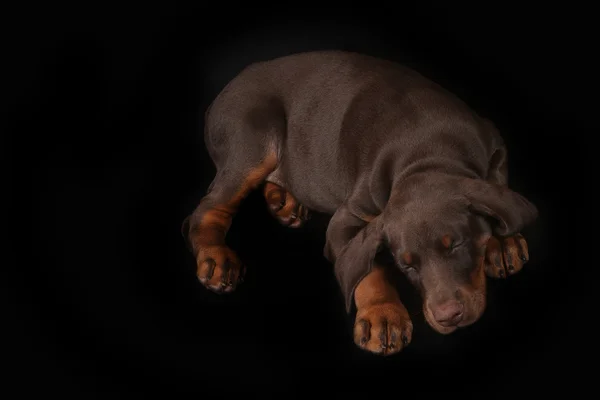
264, 182, 311, 228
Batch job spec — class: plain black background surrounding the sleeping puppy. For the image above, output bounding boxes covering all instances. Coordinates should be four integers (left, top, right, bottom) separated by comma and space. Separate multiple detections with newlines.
7, 2, 597, 399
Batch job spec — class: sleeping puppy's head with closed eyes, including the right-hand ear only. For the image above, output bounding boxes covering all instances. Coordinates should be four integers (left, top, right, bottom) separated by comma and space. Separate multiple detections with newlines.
381, 179, 537, 333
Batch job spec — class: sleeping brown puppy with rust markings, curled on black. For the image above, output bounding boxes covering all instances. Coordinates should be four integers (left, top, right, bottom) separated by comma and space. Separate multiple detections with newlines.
186, 51, 537, 354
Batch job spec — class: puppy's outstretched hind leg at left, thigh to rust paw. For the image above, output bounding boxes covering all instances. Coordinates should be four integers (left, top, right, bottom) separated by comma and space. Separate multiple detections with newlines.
184, 96, 283, 293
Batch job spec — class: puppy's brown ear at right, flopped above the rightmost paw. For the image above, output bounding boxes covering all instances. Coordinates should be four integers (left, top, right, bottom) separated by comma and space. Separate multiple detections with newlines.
463, 179, 538, 237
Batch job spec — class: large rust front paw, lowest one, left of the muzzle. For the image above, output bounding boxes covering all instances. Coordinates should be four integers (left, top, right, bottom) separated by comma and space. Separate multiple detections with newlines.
354, 302, 413, 355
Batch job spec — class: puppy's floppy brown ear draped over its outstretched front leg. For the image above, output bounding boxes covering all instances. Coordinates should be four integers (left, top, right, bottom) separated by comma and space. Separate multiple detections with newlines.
328, 216, 383, 313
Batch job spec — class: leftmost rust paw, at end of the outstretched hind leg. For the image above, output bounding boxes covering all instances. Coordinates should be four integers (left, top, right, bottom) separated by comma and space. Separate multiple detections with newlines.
196, 246, 245, 293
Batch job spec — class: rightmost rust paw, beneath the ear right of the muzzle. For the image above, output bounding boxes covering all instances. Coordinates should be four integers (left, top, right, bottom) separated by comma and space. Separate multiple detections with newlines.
485, 234, 529, 278
